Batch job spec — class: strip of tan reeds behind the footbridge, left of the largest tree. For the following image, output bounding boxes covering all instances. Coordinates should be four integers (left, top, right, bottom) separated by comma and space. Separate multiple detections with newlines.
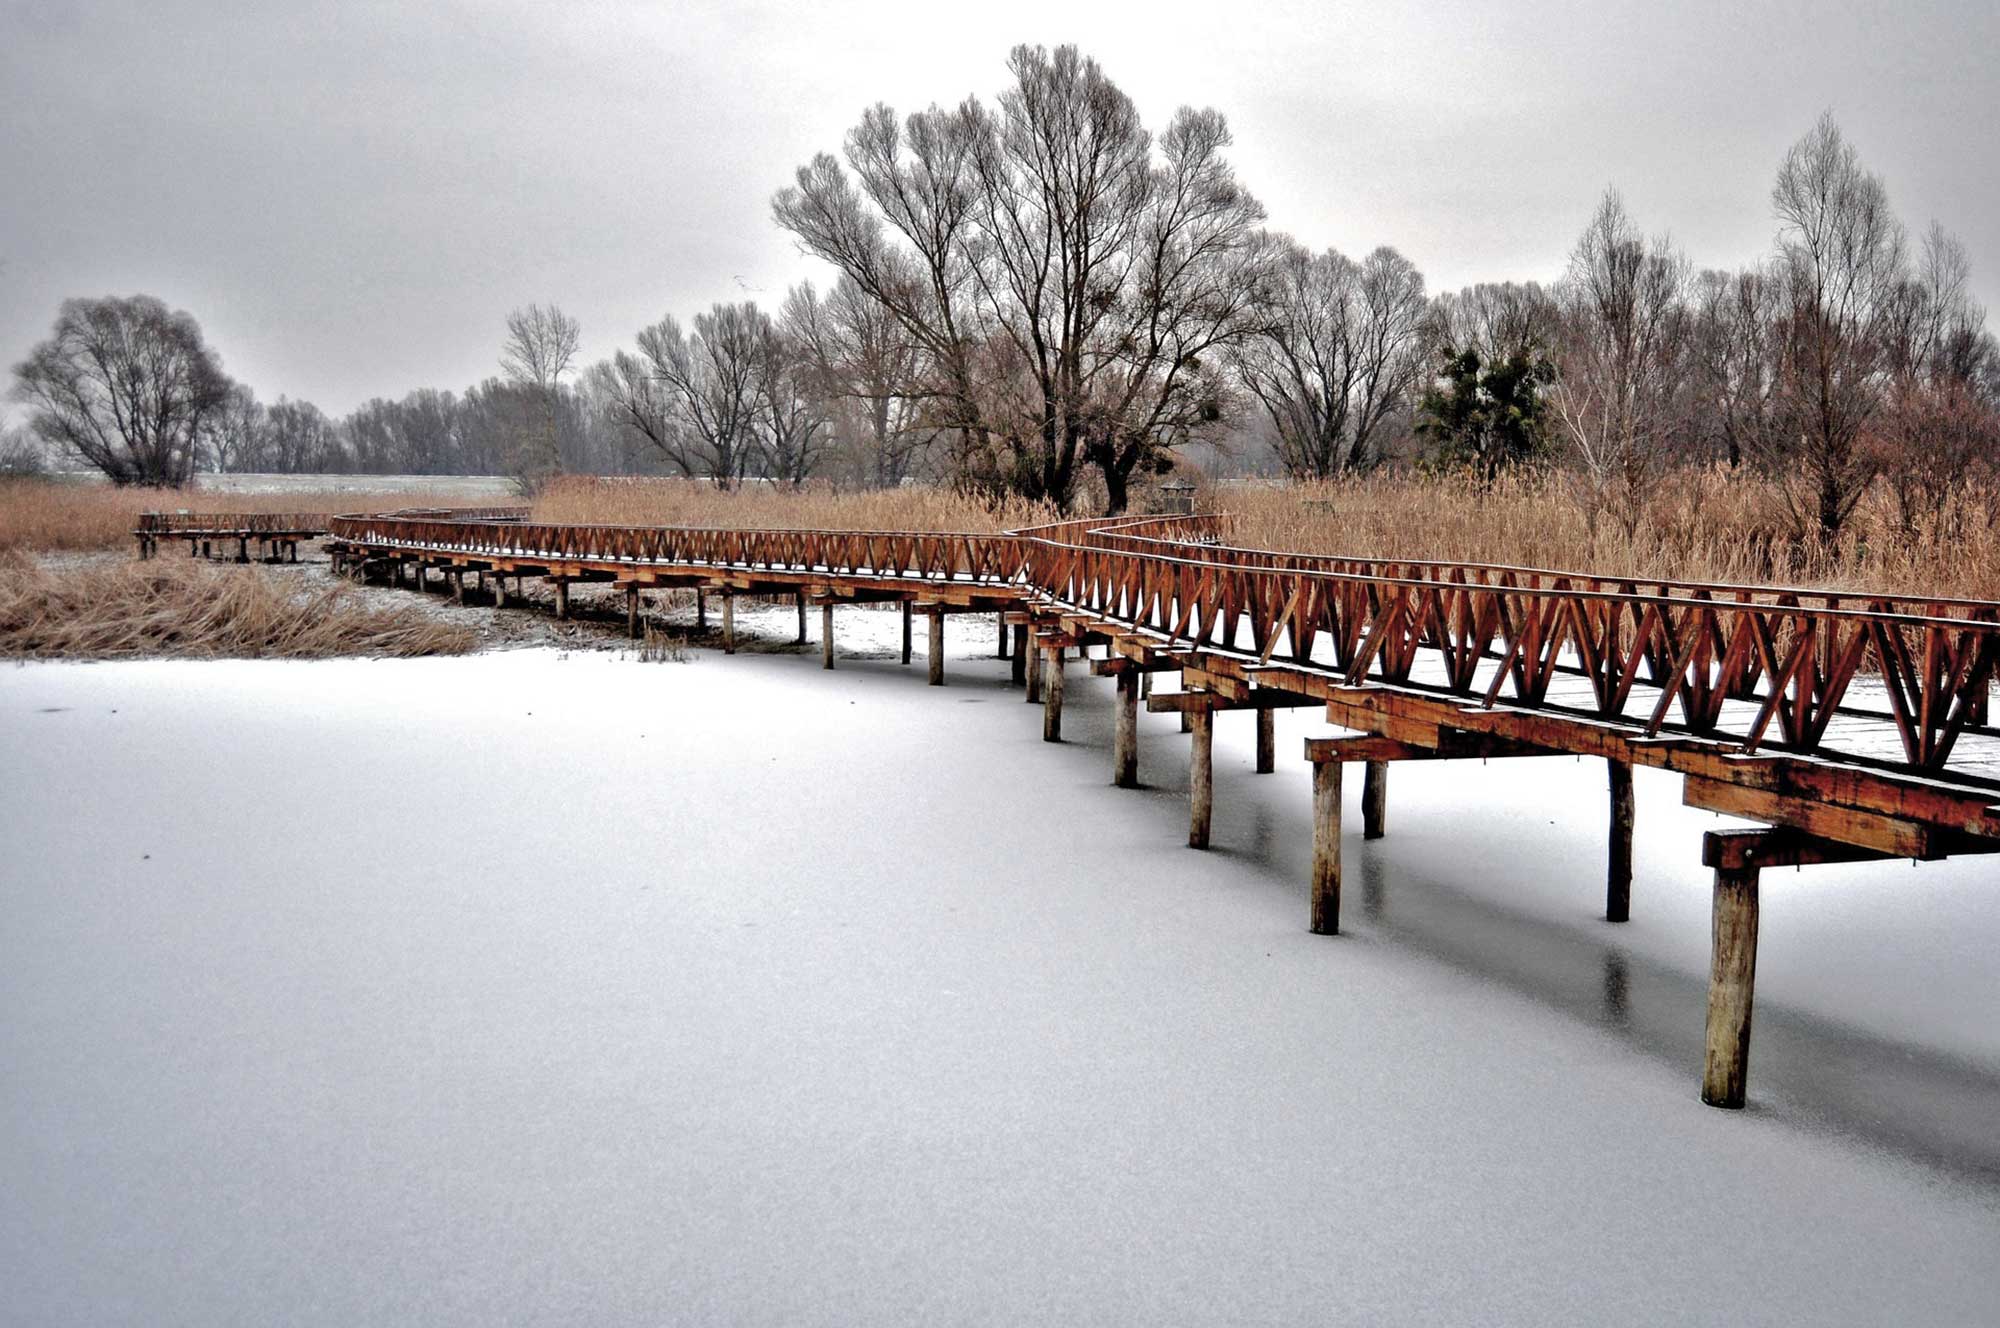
534, 476, 1056, 534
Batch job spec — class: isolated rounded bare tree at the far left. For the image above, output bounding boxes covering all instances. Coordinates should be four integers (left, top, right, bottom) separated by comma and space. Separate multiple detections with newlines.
14, 296, 230, 484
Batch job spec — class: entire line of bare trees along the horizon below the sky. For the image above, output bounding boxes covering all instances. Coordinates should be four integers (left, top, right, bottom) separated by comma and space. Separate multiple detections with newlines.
14, 46, 2000, 542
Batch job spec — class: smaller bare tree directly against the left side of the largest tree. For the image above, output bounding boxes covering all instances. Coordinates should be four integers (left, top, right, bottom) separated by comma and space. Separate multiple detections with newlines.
784, 276, 938, 488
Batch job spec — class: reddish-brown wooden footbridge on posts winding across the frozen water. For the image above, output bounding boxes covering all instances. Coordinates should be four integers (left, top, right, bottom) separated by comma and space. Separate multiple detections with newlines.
300, 510, 2000, 1106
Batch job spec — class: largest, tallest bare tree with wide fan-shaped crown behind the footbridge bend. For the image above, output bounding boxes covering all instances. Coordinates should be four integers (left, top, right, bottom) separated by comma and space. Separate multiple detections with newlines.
774, 46, 1270, 512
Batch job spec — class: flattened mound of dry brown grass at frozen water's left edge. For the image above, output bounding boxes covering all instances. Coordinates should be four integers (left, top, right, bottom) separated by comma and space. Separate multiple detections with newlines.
0, 552, 478, 660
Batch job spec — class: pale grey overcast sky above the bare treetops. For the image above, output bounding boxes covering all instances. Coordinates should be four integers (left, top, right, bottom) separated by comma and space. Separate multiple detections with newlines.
0, 0, 2000, 412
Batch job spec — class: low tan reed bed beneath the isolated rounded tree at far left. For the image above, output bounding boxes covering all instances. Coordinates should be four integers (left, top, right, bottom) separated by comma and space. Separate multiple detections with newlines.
0, 480, 492, 552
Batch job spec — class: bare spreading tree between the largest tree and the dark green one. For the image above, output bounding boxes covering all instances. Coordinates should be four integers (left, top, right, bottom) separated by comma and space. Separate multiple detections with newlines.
1236, 246, 1430, 480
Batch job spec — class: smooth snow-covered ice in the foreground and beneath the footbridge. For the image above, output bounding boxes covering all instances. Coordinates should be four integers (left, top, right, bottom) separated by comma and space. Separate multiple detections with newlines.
11, 640, 2000, 1324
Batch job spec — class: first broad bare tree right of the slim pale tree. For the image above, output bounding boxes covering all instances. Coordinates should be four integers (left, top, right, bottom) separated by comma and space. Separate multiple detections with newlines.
606, 300, 770, 488
